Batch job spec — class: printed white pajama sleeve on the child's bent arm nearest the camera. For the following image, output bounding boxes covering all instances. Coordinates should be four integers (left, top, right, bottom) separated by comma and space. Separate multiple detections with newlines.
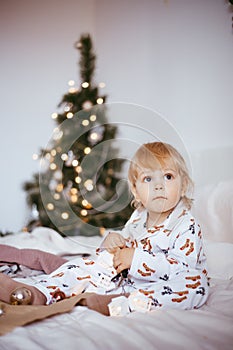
129, 222, 204, 282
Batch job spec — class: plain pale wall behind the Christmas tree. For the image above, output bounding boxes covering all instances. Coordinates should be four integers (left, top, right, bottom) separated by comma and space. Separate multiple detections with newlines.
0, 0, 233, 230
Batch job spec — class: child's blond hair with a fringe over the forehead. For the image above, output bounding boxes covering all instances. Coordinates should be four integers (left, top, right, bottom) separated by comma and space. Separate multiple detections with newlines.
128, 142, 193, 209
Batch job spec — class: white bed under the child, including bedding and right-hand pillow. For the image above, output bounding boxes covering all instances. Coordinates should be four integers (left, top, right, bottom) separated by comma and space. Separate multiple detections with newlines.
0, 148, 233, 350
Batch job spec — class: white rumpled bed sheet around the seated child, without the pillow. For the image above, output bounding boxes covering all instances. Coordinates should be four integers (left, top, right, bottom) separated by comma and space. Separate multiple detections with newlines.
0, 228, 233, 350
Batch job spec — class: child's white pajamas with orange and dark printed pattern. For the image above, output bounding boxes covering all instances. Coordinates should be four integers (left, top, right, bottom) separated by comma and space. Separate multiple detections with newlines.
35, 202, 208, 309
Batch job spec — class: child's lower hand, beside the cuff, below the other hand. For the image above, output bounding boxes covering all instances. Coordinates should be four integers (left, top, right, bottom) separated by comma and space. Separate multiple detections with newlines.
113, 248, 135, 273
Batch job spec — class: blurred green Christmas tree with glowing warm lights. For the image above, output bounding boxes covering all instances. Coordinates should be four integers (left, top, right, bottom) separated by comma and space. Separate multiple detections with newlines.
23, 35, 132, 236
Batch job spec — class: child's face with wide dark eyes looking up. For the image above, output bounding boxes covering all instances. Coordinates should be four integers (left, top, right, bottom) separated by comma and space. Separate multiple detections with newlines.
134, 162, 183, 220
